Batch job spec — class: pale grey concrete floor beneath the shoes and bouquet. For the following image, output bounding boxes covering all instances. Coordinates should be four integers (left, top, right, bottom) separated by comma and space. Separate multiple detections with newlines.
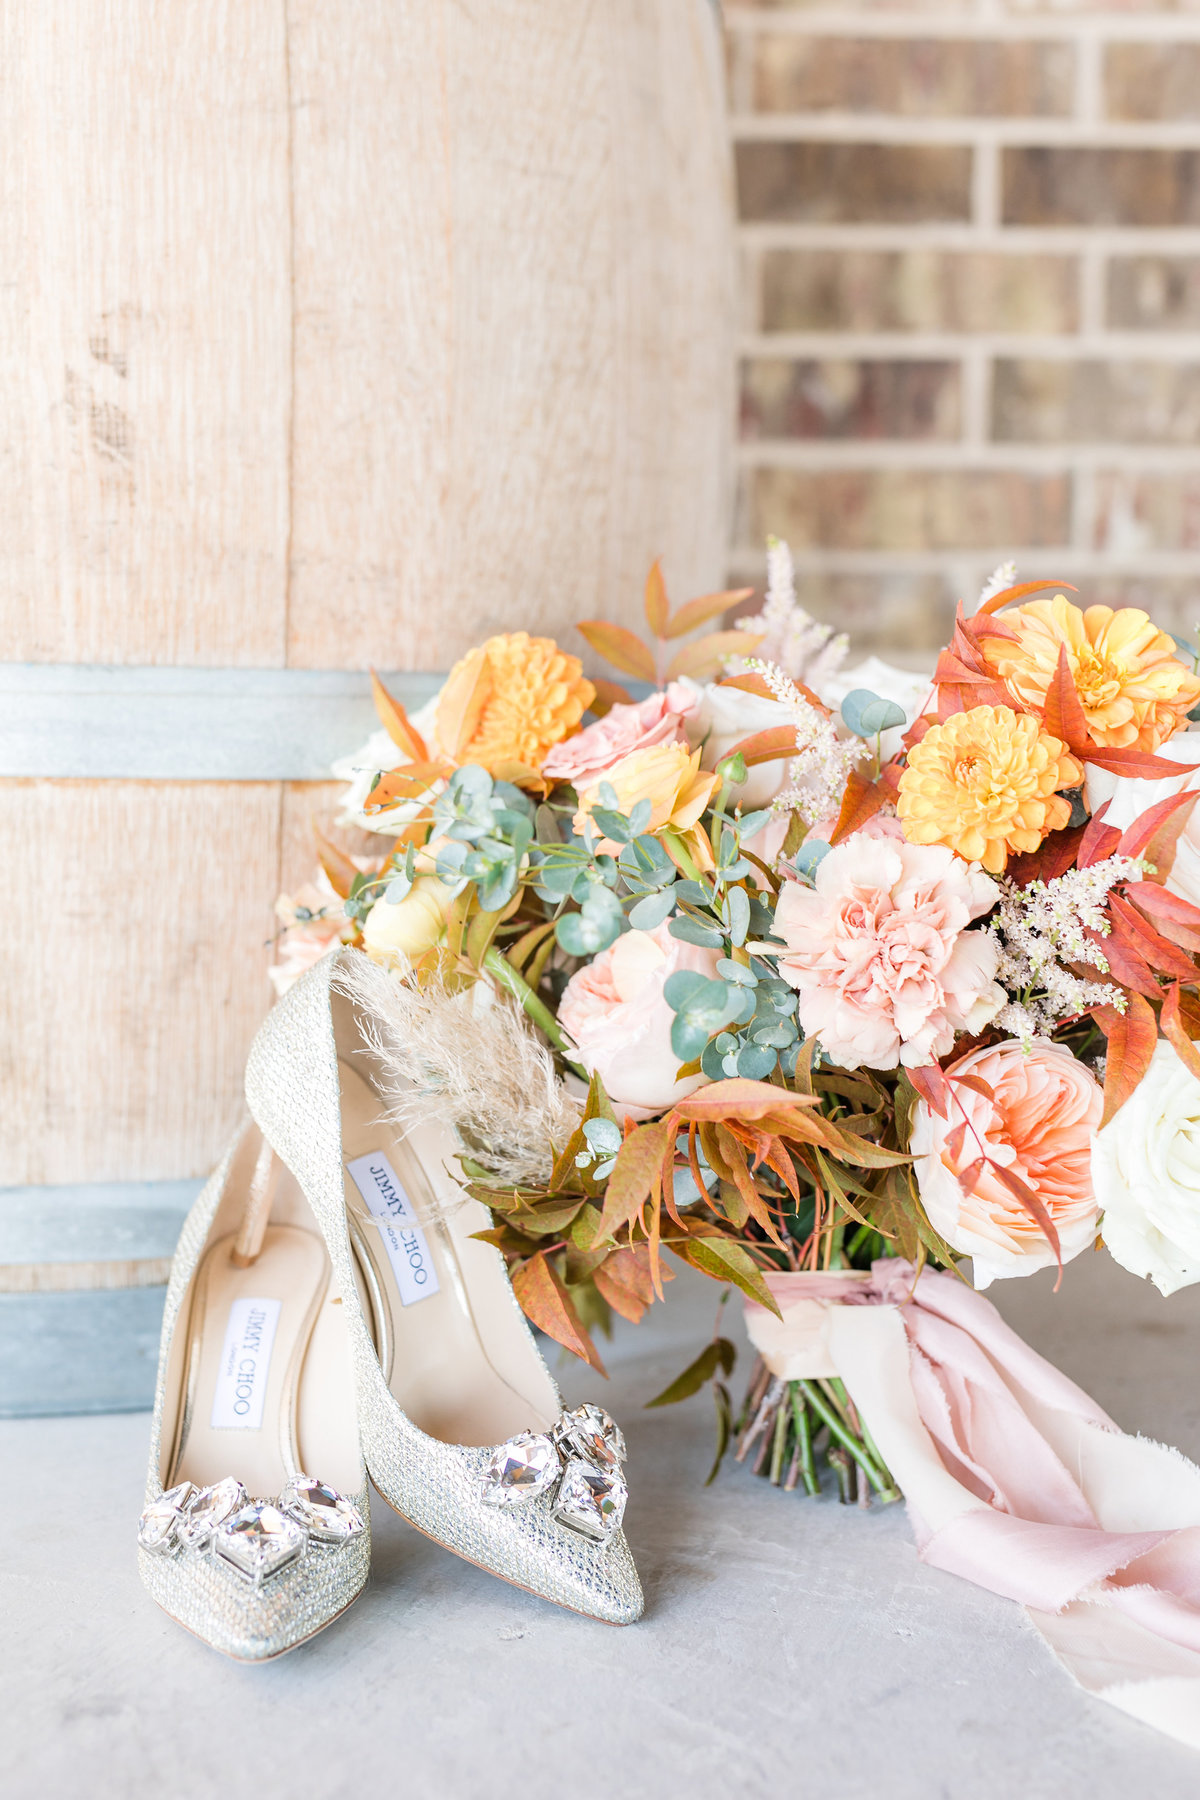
0, 1256, 1200, 1800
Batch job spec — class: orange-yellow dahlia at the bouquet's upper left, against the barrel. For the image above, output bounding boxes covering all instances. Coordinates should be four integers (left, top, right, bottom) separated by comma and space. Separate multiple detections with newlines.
437, 632, 596, 774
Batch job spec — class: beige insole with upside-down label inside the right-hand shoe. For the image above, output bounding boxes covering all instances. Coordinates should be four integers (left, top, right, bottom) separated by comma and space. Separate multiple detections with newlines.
340, 1062, 558, 1444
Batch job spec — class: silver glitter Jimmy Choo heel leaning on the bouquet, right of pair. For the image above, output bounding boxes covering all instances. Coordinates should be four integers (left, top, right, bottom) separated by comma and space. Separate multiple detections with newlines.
246, 950, 642, 1625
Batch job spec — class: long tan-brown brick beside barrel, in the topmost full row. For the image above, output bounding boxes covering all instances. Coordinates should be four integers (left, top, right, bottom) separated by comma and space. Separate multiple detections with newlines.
754, 32, 1074, 117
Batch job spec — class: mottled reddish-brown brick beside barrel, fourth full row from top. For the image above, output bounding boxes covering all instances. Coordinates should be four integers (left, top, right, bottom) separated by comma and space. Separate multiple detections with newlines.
741, 356, 959, 439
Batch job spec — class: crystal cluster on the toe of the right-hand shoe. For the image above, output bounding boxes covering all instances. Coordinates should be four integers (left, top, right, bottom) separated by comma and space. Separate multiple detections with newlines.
482, 1404, 630, 1544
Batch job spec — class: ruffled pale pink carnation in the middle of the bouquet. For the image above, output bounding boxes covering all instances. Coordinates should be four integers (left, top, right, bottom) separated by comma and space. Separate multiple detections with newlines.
775, 833, 1007, 1069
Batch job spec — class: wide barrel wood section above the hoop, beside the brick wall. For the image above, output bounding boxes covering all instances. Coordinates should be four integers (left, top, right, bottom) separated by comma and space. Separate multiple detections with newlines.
288, 0, 732, 670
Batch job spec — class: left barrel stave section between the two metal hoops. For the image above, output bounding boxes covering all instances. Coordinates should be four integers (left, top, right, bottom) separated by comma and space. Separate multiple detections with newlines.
0, 781, 281, 1186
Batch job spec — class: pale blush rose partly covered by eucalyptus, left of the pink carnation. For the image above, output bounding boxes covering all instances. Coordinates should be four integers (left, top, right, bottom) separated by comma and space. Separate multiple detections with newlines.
558, 925, 716, 1116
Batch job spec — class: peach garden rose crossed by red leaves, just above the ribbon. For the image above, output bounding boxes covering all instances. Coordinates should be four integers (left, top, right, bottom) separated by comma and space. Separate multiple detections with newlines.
909, 1039, 1105, 1287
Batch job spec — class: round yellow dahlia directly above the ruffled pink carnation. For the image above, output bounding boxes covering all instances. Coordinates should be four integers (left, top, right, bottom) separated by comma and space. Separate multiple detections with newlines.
896, 706, 1083, 875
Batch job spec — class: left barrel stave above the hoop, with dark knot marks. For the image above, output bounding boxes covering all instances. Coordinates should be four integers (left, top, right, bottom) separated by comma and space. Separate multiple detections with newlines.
0, 0, 291, 666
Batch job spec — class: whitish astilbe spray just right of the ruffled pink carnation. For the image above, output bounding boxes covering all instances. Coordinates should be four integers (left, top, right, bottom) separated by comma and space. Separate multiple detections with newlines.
990, 857, 1146, 1044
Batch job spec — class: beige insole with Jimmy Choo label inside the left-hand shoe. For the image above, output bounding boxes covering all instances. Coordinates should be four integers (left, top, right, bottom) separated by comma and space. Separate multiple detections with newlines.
164, 1224, 329, 1499
